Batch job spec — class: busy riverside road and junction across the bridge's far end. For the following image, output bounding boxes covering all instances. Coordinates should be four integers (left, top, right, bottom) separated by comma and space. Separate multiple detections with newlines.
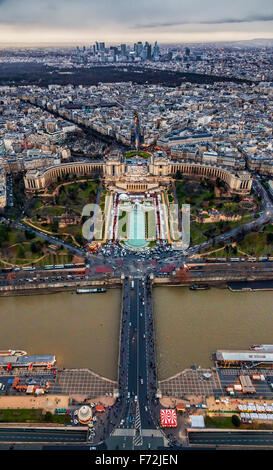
0, 254, 273, 291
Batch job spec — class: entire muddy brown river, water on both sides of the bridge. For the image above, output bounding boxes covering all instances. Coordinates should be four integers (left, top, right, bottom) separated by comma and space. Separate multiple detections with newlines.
0, 287, 273, 379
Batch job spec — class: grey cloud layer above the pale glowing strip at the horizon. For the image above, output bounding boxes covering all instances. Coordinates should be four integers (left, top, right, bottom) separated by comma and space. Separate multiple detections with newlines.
0, 0, 273, 28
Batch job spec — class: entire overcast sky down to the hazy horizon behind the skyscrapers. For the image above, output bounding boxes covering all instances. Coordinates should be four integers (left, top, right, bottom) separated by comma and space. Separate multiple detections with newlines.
0, 0, 273, 43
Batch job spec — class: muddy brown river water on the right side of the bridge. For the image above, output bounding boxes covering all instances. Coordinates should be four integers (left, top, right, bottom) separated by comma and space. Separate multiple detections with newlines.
153, 287, 273, 379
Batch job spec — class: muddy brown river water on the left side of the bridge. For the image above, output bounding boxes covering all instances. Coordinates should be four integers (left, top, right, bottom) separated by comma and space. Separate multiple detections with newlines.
0, 289, 121, 380
